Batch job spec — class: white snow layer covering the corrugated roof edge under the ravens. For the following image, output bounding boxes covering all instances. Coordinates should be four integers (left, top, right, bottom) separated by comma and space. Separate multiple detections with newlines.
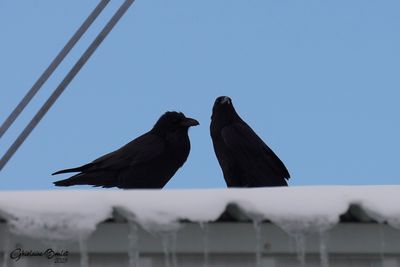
0, 186, 400, 240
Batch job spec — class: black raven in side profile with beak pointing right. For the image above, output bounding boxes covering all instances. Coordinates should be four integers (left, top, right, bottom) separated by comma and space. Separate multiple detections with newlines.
53, 112, 199, 188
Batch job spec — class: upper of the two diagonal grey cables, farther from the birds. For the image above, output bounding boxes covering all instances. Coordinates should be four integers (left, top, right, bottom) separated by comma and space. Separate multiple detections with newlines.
0, 0, 110, 138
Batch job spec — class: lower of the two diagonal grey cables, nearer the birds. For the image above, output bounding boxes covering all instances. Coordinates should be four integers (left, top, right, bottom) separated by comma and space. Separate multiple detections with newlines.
0, 0, 135, 171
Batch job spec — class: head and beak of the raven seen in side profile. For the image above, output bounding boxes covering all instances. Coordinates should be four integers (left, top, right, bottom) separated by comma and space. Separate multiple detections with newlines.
153, 111, 199, 135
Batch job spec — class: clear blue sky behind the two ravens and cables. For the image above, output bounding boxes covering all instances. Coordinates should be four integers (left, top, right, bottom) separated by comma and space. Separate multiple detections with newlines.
0, 0, 400, 189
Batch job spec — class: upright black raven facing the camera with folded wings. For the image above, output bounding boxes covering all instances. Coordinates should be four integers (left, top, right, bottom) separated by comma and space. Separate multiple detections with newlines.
210, 96, 290, 187
